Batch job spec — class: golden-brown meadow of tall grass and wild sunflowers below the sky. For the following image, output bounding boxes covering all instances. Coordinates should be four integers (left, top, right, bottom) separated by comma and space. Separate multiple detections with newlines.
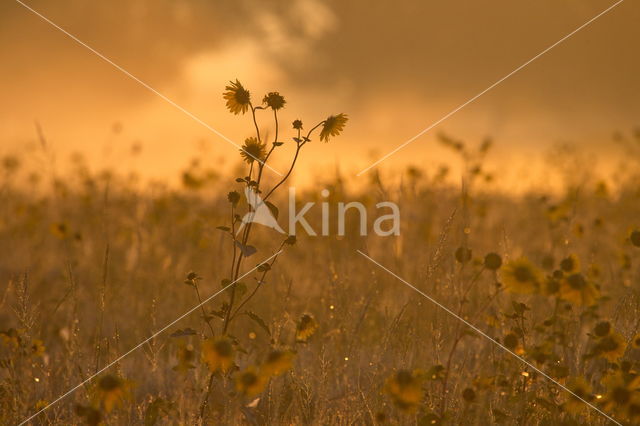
0, 86, 640, 425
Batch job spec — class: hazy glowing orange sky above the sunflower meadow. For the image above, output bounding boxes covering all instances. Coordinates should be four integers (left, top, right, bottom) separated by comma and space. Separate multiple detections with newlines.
0, 0, 640, 190
